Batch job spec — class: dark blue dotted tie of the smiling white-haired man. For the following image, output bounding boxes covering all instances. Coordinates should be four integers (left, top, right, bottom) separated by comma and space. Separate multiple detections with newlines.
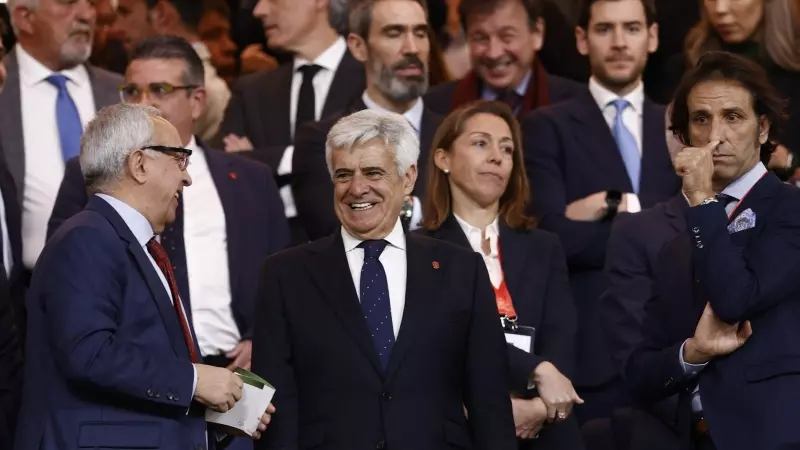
358, 239, 394, 370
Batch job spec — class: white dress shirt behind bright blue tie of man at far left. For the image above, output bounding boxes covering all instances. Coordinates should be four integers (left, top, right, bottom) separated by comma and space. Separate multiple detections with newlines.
16, 44, 95, 268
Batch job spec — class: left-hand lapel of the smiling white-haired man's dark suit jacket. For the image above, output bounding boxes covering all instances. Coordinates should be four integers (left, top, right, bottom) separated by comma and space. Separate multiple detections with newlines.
306, 229, 383, 374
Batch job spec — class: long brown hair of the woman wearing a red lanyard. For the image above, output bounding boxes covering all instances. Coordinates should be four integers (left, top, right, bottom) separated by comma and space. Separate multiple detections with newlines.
422, 100, 536, 231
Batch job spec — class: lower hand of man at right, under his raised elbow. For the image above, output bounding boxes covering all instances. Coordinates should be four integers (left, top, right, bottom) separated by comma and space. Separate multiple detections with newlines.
683, 303, 753, 364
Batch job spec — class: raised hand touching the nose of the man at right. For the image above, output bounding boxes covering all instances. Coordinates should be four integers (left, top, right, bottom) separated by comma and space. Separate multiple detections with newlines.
673, 141, 719, 206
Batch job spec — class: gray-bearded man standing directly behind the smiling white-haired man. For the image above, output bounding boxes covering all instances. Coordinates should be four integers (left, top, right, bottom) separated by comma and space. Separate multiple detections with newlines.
292, 0, 442, 239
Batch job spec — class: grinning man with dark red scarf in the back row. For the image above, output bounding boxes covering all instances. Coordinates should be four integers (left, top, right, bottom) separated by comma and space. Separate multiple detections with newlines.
425, 0, 584, 117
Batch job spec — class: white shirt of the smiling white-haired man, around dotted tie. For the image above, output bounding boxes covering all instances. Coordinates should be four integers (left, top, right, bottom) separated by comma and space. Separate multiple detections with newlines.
342, 219, 408, 338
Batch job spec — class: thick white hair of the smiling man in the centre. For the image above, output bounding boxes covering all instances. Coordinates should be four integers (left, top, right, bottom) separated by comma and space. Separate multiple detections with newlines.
325, 109, 419, 176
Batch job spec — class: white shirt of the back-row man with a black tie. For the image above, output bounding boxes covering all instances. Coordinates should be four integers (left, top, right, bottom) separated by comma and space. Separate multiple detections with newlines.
277, 37, 347, 217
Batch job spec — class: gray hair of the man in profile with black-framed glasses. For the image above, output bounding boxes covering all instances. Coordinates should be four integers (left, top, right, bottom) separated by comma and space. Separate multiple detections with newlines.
80, 103, 163, 193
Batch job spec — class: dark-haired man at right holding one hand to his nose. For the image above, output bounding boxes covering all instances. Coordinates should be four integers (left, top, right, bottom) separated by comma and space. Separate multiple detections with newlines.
625, 52, 800, 450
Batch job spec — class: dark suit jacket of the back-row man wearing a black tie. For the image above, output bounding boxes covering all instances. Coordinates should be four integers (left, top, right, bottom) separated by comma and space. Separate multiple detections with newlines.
219, 51, 366, 171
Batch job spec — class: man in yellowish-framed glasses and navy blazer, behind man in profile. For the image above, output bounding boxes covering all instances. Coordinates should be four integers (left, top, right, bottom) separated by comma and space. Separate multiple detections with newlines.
48, 36, 289, 386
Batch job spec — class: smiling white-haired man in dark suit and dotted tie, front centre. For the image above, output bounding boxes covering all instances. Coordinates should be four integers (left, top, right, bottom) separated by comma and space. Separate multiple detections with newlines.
253, 109, 517, 450
